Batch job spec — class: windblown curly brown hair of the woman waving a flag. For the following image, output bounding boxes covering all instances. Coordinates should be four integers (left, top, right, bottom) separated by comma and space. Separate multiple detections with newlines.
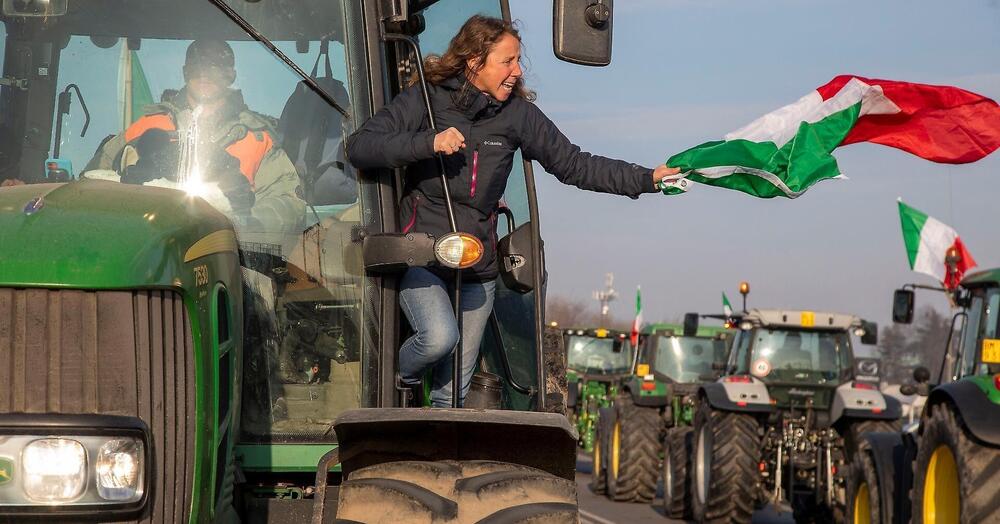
411, 15, 535, 101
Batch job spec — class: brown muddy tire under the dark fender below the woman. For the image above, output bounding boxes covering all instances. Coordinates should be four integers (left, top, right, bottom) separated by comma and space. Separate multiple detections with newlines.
337, 460, 579, 524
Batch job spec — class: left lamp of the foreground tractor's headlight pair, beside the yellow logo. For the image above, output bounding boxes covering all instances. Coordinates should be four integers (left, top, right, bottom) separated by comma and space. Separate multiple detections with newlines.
21, 438, 87, 502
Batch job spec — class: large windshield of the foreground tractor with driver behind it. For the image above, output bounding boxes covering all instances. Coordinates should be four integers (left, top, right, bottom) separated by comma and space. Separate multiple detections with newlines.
0, 0, 381, 440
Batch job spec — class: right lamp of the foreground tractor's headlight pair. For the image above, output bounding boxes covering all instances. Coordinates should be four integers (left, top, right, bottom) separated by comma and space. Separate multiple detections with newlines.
94, 438, 143, 502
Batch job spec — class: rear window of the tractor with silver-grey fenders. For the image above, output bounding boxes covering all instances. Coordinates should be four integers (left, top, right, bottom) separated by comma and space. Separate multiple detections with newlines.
750, 328, 851, 384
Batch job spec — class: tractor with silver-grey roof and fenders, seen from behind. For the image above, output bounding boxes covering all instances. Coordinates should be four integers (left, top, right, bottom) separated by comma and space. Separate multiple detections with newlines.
688, 309, 901, 523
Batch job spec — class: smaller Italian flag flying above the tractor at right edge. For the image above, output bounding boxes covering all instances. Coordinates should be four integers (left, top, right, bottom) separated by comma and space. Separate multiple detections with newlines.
899, 199, 976, 289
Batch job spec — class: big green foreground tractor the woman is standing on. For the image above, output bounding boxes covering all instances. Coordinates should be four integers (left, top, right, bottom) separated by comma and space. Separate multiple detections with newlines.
0, 0, 611, 524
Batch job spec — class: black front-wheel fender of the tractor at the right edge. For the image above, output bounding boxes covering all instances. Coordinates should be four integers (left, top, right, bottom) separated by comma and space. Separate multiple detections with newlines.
862, 432, 917, 524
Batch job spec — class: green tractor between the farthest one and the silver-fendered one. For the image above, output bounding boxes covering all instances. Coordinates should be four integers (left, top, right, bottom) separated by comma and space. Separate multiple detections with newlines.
591, 314, 731, 506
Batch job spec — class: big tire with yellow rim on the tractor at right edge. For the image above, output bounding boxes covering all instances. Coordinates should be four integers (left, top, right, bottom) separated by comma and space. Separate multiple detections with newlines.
912, 403, 1000, 524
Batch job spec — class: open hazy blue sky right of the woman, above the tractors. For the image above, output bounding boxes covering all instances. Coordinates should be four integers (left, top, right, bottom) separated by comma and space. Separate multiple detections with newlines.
510, 0, 1000, 324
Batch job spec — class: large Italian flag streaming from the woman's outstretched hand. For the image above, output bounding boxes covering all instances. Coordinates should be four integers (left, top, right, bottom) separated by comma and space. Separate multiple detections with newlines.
661, 75, 1000, 198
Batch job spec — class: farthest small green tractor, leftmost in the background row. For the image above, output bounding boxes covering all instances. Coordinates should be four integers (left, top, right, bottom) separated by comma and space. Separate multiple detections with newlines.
563, 328, 633, 453
